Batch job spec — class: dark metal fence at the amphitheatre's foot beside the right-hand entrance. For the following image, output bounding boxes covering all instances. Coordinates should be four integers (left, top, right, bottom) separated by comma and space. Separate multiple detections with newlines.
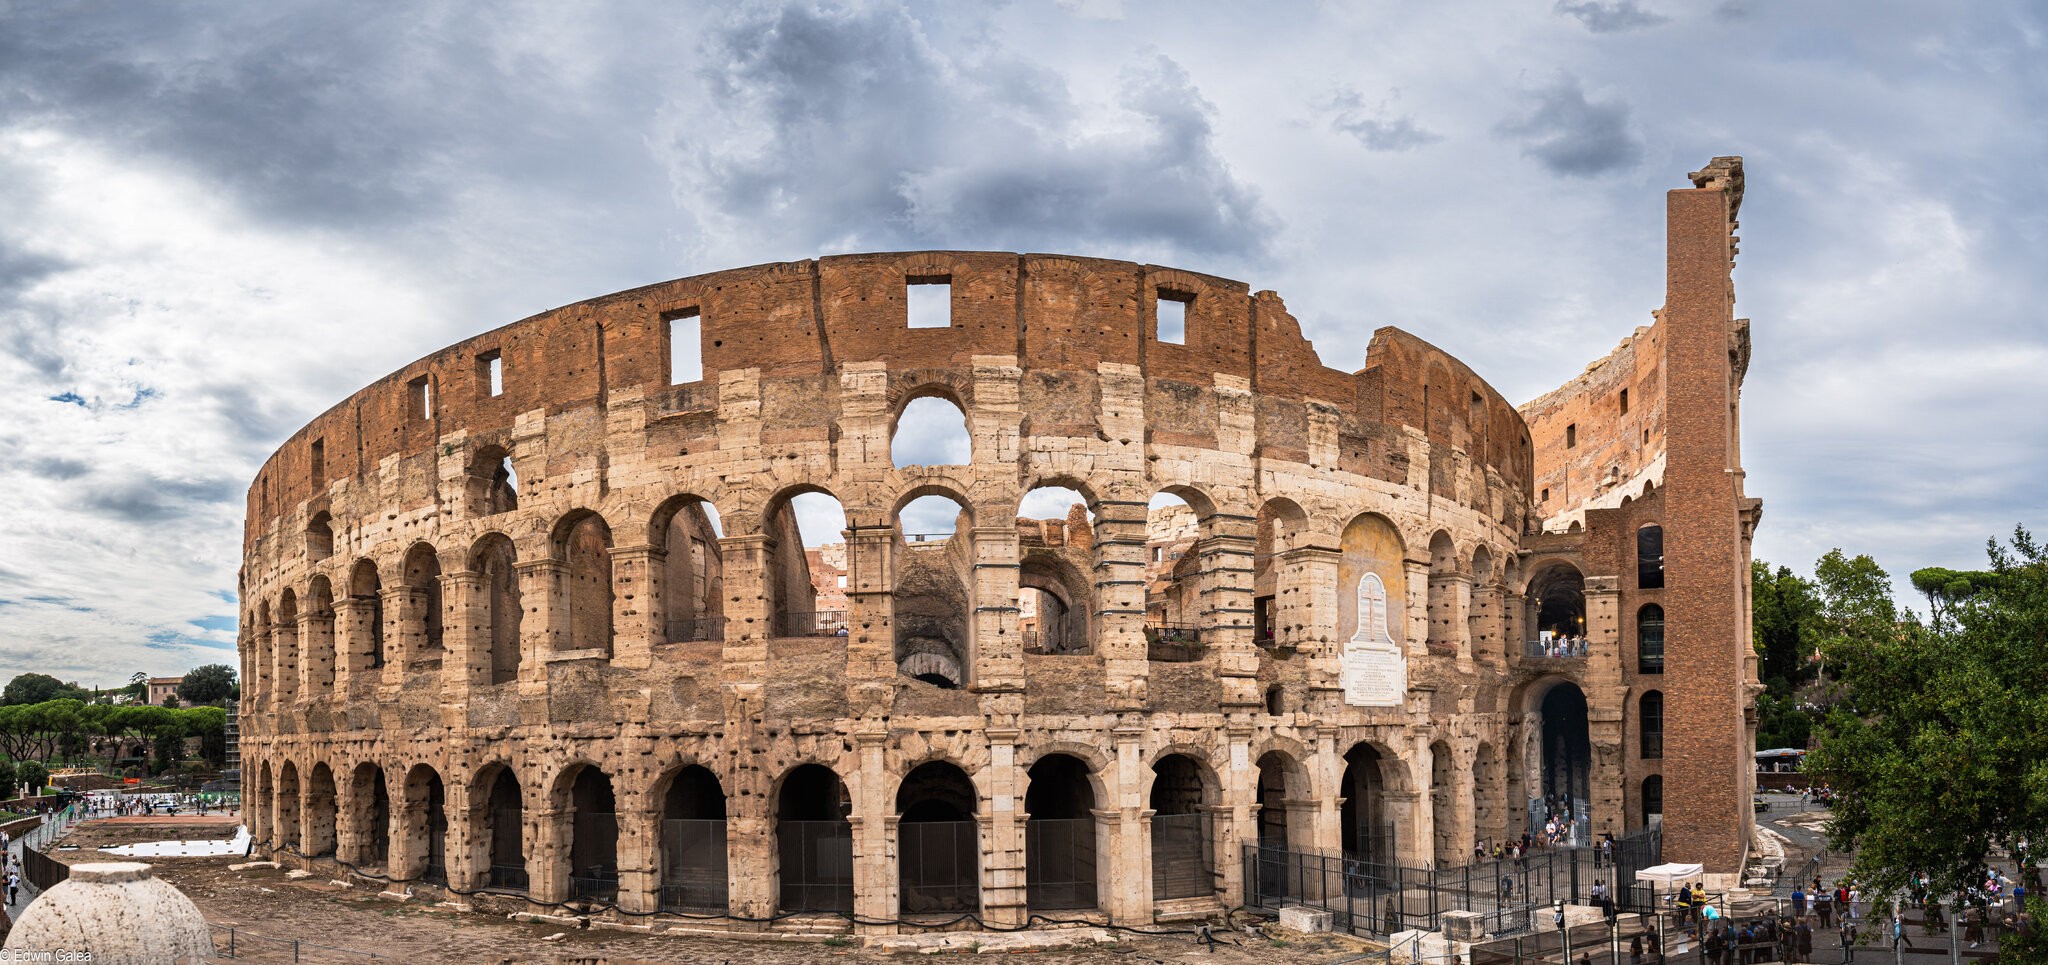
1236, 817, 1663, 936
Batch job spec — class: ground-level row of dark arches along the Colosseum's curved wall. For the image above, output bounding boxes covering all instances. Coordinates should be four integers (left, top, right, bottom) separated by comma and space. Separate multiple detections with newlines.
250, 729, 1540, 916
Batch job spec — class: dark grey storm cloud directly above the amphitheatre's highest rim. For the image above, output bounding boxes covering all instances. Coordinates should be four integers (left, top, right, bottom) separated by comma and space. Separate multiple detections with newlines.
676, 6, 1276, 254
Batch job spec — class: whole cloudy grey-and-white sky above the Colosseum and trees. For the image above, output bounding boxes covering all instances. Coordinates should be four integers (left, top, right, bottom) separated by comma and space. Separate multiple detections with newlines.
0, 0, 2048, 684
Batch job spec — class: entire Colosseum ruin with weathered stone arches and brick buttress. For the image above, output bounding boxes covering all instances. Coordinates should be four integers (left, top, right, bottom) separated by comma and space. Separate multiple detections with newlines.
240, 158, 1759, 932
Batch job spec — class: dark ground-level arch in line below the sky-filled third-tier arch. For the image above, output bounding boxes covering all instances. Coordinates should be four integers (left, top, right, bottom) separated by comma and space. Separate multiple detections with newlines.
897, 760, 981, 914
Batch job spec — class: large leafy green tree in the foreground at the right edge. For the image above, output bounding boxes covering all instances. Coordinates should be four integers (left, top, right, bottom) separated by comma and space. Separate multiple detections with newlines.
1806, 529, 2048, 909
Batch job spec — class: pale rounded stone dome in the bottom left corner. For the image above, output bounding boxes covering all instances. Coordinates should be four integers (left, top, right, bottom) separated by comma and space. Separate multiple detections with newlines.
4, 861, 213, 965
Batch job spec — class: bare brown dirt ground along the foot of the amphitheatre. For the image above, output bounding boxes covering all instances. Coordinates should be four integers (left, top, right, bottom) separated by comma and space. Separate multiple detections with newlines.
39, 820, 1368, 965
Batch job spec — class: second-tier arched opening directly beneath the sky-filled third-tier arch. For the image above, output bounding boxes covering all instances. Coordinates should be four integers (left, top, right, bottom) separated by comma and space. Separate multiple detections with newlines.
891, 494, 975, 690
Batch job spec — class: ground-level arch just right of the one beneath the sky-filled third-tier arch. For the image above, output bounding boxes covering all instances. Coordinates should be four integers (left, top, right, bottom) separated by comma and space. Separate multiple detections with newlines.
1024, 754, 1100, 912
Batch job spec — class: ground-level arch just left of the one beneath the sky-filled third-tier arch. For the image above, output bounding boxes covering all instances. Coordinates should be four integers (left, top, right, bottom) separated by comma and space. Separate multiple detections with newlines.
774, 764, 854, 912
